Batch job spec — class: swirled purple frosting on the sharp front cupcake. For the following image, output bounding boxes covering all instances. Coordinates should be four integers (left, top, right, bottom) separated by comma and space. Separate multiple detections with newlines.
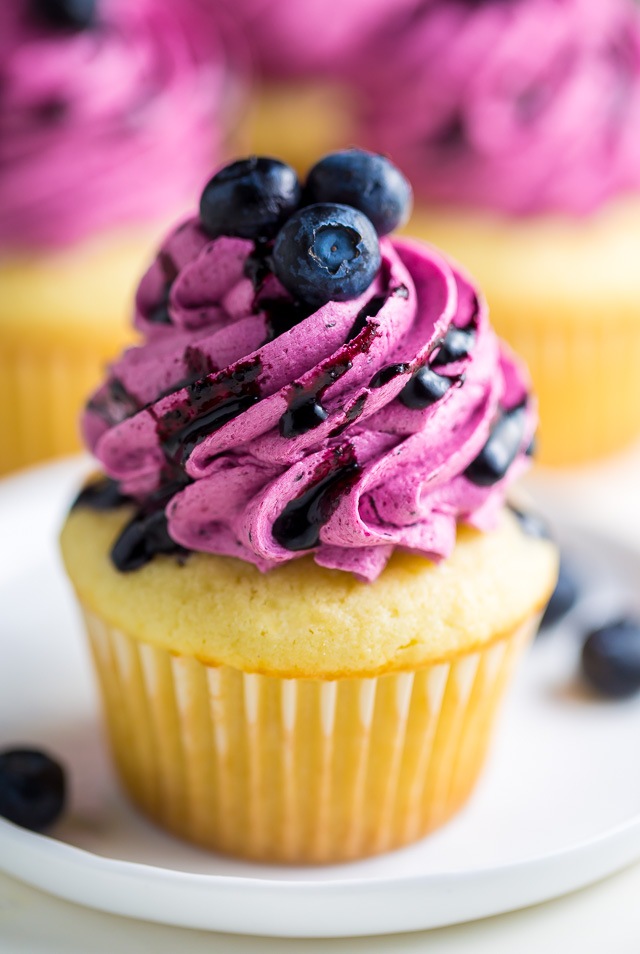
83, 219, 535, 580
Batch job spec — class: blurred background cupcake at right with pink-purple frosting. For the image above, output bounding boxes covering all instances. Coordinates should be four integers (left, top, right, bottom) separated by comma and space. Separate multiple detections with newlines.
358, 0, 640, 464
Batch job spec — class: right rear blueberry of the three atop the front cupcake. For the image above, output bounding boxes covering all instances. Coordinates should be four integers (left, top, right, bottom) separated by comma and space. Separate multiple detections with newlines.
305, 149, 412, 235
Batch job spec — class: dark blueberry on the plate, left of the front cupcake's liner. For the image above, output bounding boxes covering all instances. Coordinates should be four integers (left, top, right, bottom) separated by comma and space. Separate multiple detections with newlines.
0, 749, 66, 831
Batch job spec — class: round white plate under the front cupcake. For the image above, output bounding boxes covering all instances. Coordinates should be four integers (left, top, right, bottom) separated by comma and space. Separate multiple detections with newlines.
0, 460, 640, 937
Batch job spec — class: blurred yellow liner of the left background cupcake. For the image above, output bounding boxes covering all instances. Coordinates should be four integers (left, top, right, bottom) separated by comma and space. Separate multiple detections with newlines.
0, 342, 124, 474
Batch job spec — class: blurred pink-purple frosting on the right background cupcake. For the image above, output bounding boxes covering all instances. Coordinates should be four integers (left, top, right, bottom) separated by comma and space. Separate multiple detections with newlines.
355, 0, 640, 214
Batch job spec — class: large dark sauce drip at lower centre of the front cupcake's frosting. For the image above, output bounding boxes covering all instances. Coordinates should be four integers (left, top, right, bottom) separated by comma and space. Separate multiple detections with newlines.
272, 444, 361, 552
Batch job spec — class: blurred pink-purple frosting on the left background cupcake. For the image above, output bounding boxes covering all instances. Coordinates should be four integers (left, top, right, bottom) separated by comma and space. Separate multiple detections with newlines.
0, 0, 242, 249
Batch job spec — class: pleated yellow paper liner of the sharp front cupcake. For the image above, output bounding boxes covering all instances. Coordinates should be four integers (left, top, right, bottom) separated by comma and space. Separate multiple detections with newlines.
85, 610, 538, 863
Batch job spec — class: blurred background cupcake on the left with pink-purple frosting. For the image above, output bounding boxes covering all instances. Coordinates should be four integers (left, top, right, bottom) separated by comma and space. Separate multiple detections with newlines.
0, 0, 245, 473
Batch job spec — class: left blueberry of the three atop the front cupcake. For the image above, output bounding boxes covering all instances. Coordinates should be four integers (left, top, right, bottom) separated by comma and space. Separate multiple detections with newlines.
200, 156, 301, 240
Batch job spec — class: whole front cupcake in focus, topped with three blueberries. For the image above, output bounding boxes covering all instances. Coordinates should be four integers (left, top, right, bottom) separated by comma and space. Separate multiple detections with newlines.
62, 150, 557, 862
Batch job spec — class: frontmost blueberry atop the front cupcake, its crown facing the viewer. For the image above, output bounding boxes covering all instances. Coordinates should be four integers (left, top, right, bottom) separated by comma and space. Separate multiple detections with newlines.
273, 203, 380, 307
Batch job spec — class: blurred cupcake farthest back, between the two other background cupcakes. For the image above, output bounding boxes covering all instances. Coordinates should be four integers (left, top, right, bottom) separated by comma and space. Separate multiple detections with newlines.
222, 0, 415, 174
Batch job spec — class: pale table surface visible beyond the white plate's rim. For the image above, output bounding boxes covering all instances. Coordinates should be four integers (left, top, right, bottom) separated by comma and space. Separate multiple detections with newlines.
0, 444, 640, 954
